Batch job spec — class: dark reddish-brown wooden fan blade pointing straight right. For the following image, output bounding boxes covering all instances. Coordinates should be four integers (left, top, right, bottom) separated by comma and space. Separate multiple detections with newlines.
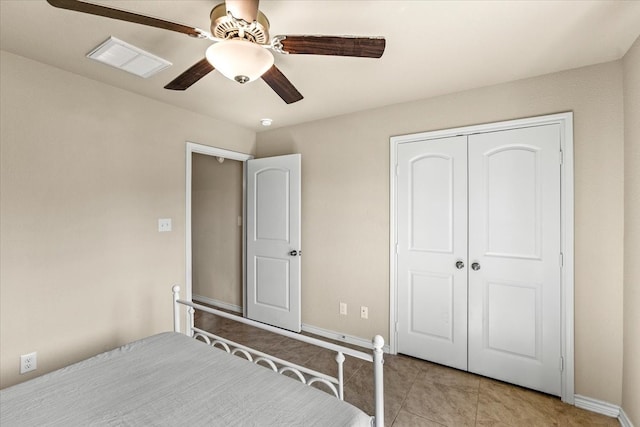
276, 36, 386, 58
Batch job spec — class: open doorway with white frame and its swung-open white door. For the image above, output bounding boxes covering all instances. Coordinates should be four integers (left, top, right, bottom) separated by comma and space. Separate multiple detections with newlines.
185, 142, 302, 332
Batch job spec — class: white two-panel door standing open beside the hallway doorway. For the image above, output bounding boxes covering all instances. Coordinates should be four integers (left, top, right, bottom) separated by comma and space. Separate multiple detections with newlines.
246, 154, 301, 332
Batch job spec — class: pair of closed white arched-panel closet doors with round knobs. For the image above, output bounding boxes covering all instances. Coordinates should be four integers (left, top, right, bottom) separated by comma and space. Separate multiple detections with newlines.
392, 118, 563, 395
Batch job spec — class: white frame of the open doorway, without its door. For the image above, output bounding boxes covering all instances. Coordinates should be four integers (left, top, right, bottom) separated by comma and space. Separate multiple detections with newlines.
185, 141, 253, 318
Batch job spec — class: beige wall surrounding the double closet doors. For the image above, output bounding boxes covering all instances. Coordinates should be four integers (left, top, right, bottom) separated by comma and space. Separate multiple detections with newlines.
257, 61, 624, 405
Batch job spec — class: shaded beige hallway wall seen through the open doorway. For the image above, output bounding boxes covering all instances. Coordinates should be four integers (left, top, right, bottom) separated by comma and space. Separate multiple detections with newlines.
191, 153, 243, 307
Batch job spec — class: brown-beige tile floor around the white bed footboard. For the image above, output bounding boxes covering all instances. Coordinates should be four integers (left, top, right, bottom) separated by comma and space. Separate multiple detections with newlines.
195, 311, 620, 427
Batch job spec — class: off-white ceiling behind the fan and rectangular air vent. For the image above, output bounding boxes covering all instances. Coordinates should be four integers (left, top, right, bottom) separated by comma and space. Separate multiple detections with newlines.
0, 0, 640, 131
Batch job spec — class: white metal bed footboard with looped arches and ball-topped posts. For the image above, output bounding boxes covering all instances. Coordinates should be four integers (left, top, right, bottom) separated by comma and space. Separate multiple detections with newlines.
173, 285, 384, 427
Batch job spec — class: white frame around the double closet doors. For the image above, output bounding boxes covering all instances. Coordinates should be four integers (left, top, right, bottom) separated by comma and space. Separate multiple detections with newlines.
389, 112, 575, 405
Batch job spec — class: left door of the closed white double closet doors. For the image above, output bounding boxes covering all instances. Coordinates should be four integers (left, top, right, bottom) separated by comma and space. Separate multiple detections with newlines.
396, 136, 467, 370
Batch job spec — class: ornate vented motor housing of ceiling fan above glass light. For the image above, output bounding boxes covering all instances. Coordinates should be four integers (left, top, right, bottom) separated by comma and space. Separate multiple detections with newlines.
210, 3, 269, 44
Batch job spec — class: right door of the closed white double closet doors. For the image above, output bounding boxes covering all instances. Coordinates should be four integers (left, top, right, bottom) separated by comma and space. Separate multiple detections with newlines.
468, 125, 561, 395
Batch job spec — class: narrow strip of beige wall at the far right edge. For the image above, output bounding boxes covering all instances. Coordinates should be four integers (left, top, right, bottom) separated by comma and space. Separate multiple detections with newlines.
622, 38, 640, 426
